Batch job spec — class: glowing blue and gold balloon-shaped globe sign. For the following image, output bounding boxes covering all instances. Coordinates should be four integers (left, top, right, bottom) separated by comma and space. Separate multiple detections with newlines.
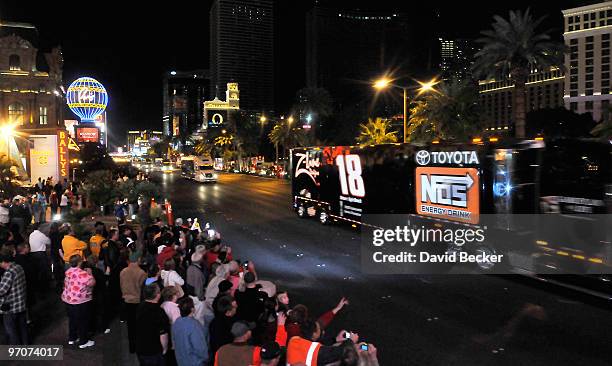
66, 77, 108, 123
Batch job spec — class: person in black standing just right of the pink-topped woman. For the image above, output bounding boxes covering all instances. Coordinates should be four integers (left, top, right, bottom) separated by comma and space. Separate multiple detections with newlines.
87, 254, 112, 334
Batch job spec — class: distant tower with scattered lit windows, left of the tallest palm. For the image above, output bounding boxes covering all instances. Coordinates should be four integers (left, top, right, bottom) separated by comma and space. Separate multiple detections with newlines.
438, 38, 477, 80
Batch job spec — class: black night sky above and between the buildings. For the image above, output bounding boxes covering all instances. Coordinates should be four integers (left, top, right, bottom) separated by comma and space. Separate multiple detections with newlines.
0, 0, 596, 145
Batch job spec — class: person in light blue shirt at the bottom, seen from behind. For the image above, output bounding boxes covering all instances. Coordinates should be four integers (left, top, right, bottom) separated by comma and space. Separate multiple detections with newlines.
172, 296, 209, 366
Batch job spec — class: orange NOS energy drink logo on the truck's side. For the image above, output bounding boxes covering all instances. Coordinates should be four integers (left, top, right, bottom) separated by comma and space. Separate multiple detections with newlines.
415, 167, 480, 224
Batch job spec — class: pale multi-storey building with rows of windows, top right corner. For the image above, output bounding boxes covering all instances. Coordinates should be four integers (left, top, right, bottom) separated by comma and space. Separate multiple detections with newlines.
562, 1, 612, 121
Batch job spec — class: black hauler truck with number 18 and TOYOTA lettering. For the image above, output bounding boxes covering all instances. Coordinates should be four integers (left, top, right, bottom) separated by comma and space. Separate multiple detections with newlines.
290, 139, 612, 293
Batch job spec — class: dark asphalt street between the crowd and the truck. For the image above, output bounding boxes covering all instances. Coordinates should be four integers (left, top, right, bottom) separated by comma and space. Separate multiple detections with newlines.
162, 174, 612, 365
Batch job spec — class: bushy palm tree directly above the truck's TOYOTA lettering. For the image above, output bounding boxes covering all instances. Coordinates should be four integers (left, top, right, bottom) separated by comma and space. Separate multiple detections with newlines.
407, 80, 482, 142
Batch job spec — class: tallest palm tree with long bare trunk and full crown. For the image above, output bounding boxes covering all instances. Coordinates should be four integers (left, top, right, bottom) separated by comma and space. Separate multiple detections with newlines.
473, 9, 565, 138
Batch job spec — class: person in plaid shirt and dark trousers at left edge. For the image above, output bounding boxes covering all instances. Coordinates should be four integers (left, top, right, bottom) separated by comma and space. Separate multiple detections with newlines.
0, 247, 29, 345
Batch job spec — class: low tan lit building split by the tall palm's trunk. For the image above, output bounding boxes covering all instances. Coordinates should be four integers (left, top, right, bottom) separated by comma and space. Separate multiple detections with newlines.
478, 68, 565, 131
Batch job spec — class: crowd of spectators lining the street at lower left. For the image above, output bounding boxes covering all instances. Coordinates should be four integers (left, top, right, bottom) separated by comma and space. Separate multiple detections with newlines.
0, 187, 378, 366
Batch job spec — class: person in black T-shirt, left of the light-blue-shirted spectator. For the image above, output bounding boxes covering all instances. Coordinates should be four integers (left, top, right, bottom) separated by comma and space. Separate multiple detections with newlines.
134, 284, 170, 366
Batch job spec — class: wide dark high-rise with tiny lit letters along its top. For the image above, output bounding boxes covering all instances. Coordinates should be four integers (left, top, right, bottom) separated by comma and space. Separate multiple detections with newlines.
306, 6, 410, 106
